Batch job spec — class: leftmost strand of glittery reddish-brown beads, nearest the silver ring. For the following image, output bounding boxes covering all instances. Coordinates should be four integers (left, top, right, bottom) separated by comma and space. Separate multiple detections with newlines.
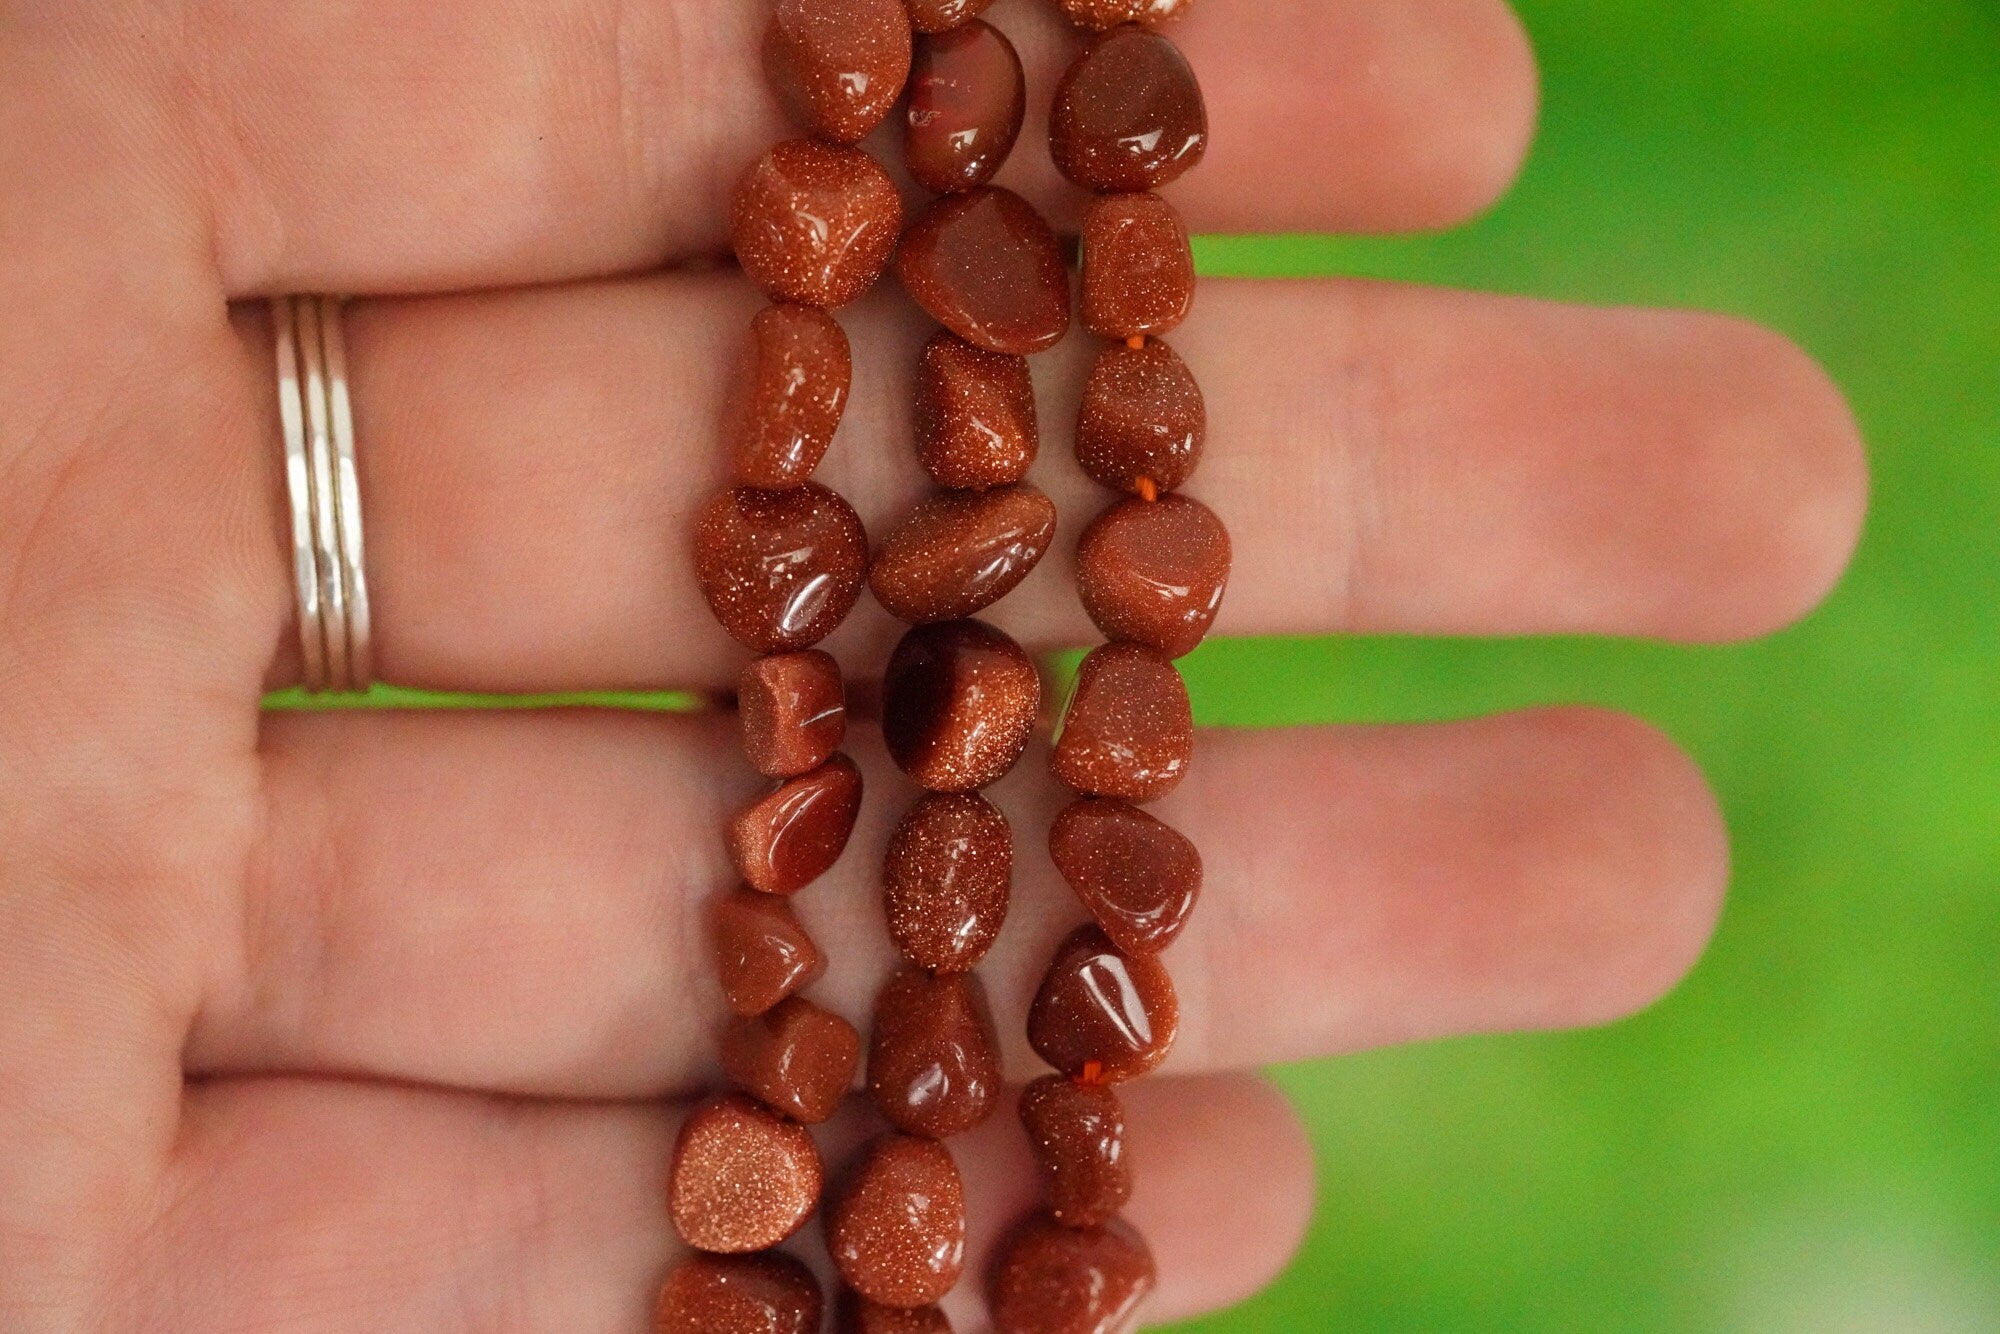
656, 0, 910, 1334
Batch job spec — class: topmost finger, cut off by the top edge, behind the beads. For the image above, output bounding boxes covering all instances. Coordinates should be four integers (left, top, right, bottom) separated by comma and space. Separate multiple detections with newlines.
172, 0, 1536, 294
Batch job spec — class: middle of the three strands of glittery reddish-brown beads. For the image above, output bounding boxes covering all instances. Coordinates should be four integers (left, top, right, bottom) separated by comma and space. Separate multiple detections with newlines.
828, 0, 1070, 1334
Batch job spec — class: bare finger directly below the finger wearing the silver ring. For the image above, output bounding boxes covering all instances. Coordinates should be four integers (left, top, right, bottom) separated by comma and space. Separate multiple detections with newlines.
186, 710, 1726, 1098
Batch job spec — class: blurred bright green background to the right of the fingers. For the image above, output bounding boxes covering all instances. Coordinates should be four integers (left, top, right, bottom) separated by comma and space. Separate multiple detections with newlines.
1184, 0, 2000, 1334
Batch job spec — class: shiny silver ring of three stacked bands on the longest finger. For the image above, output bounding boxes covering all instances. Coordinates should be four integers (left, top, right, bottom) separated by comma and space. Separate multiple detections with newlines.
272, 296, 374, 692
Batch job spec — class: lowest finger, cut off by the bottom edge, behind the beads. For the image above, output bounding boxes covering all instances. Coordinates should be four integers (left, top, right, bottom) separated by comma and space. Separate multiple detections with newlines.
156, 1080, 1312, 1334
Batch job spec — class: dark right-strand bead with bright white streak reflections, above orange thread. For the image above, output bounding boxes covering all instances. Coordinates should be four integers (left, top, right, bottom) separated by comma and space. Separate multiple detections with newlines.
1028, 926, 1180, 1084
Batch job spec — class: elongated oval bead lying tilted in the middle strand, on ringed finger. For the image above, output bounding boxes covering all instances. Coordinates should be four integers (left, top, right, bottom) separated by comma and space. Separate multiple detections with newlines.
868, 482, 1056, 624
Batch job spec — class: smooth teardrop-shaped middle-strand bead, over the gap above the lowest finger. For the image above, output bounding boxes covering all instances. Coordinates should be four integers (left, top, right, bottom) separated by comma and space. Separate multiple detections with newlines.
868, 968, 1000, 1140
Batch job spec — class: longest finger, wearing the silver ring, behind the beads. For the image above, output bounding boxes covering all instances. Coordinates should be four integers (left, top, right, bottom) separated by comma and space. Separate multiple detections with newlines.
244, 276, 1866, 690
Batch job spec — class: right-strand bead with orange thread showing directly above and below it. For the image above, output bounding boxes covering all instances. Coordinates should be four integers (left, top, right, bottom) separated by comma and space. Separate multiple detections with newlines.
1076, 340, 1208, 492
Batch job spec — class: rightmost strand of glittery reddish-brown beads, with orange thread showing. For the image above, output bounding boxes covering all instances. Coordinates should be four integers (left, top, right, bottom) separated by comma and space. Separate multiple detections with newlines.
990, 0, 1230, 1334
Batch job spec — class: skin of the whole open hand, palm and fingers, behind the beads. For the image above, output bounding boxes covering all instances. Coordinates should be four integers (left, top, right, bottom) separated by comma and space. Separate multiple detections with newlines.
0, 0, 1866, 1334
